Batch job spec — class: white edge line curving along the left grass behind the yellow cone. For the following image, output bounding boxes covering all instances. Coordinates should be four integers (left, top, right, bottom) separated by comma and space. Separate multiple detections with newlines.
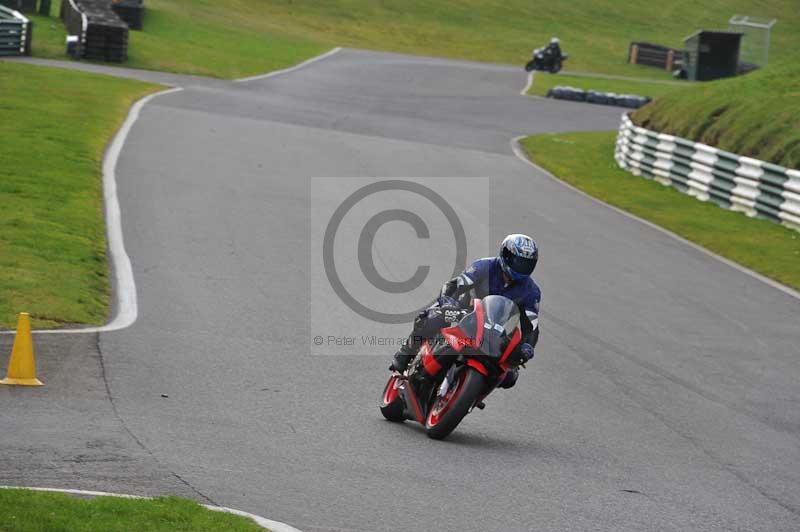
0, 87, 183, 334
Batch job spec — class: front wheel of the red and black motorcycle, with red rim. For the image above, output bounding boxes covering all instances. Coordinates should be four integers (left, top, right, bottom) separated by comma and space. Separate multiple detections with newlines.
425, 366, 486, 440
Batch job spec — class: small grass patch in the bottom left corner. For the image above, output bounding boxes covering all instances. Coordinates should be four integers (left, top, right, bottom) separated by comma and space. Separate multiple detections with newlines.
0, 489, 264, 532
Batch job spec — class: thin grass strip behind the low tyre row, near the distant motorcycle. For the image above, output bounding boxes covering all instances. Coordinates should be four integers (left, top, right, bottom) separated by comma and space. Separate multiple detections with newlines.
528, 72, 694, 98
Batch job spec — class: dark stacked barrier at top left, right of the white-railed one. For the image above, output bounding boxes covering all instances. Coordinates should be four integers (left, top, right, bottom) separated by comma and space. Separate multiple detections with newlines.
61, 0, 128, 63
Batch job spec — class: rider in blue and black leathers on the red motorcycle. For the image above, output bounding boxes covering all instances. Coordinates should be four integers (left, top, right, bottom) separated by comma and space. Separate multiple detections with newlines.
389, 234, 541, 388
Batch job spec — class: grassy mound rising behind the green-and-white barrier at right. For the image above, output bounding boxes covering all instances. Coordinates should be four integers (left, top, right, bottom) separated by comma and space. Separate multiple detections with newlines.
633, 61, 800, 168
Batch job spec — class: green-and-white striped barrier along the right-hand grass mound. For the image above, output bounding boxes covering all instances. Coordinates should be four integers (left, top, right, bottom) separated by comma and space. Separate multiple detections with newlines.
614, 114, 800, 230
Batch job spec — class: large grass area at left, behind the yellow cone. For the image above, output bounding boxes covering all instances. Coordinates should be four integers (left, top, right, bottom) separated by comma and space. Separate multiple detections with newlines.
0, 62, 157, 328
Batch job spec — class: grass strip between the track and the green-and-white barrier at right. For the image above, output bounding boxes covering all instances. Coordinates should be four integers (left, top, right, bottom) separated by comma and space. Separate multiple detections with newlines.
521, 132, 800, 289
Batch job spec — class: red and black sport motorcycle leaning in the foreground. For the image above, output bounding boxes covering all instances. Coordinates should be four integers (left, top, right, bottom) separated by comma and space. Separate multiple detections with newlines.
380, 295, 532, 440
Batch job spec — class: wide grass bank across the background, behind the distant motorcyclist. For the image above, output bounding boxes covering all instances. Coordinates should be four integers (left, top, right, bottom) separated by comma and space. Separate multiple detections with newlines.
26, 0, 800, 78
